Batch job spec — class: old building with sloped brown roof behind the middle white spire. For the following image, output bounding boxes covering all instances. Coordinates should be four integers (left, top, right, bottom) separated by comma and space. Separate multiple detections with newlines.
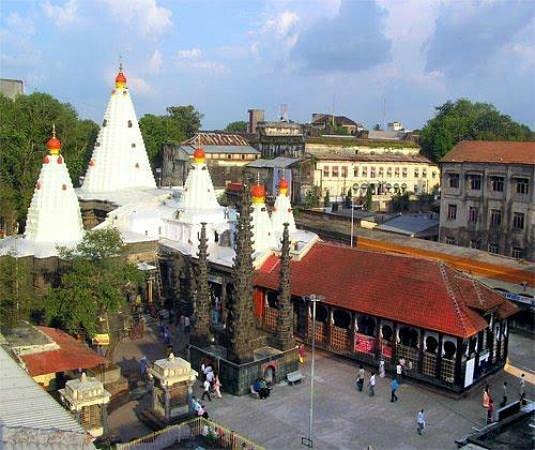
161, 132, 260, 188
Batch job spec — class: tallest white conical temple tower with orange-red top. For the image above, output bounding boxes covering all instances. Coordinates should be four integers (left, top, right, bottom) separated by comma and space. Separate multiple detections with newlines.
80, 66, 156, 194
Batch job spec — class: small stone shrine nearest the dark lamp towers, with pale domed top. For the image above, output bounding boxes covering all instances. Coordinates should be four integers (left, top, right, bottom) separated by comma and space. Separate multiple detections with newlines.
151, 353, 198, 423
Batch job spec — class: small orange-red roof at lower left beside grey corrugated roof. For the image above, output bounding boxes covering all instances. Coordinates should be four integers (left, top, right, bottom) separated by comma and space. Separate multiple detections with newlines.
20, 327, 106, 377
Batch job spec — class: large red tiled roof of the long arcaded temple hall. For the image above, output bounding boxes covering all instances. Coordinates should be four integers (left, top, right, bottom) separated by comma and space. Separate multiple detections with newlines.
255, 243, 516, 337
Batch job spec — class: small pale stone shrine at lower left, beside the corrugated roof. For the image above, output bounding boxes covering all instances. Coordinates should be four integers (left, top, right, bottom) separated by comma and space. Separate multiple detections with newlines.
59, 372, 111, 437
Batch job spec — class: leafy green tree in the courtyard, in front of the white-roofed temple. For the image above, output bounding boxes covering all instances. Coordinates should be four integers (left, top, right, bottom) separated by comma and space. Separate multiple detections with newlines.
44, 228, 143, 335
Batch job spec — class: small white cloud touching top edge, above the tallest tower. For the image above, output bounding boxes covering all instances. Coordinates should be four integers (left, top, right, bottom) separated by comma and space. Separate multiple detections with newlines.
105, 0, 173, 37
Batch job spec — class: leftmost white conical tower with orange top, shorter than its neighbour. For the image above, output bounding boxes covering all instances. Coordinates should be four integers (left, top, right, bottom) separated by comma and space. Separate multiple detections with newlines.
24, 129, 84, 245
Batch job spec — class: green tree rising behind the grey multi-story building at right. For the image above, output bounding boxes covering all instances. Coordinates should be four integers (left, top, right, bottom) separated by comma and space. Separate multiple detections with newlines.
421, 99, 535, 161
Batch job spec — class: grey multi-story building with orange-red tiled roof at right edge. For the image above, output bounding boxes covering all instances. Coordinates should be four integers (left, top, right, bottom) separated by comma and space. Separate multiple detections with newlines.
440, 141, 535, 260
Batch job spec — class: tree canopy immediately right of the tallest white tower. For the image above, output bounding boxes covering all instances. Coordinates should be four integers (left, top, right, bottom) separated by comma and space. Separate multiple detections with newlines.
139, 105, 203, 166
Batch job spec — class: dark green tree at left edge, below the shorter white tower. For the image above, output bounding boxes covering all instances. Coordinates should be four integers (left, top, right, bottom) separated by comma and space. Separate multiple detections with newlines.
0, 255, 37, 328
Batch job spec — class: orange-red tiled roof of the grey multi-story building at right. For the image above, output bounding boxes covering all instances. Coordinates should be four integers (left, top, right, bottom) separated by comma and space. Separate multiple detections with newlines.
440, 141, 535, 164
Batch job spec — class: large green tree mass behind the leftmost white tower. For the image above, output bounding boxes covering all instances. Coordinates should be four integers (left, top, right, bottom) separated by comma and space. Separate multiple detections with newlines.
0, 92, 98, 232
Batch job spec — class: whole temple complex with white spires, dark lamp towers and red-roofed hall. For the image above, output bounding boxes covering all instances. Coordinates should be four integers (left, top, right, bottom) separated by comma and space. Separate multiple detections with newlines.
0, 61, 515, 402
